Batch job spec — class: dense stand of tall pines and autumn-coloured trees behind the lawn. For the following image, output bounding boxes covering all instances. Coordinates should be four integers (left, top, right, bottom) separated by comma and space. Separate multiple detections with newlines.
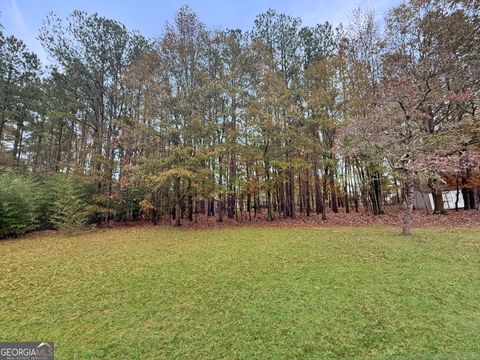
0, 0, 480, 237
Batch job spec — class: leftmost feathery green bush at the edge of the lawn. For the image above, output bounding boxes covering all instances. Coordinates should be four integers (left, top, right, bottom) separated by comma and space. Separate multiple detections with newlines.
0, 173, 39, 238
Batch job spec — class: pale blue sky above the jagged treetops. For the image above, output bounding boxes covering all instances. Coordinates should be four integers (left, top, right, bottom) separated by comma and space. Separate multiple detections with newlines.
0, 0, 400, 62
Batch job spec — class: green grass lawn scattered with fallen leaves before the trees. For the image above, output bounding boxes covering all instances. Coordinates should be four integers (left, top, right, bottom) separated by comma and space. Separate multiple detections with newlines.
0, 227, 480, 359
